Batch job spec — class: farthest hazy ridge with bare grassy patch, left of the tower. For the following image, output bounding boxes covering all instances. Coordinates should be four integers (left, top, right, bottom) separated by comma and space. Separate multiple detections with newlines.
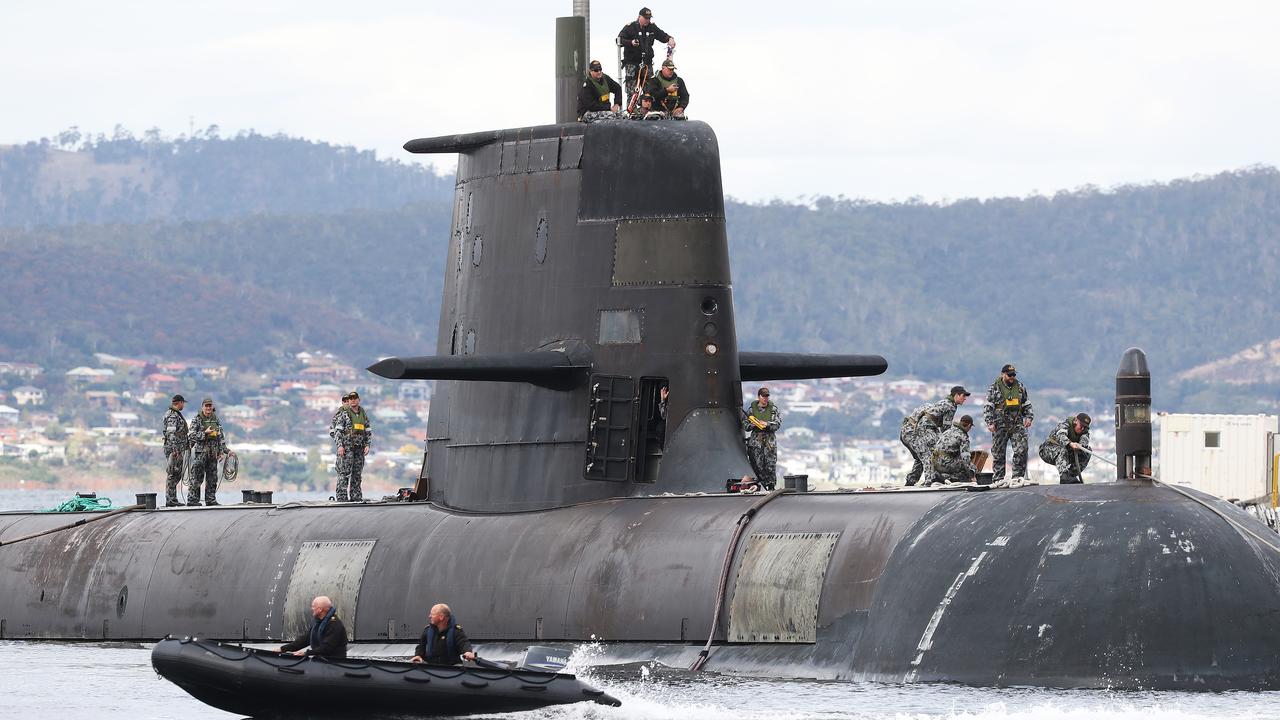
0, 126, 453, 228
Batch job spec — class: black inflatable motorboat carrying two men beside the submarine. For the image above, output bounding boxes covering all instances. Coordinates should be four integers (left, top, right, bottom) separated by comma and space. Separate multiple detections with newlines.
151, 638, 622, 717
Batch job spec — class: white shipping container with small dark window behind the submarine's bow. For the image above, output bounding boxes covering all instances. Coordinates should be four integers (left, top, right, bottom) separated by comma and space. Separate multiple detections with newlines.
1156, 413, 1280, 500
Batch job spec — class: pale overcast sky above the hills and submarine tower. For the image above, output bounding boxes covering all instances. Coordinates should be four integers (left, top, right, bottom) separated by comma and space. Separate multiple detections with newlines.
0, 0, 1280, 200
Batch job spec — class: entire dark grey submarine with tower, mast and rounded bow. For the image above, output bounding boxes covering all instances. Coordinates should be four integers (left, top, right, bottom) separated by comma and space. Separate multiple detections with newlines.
0, 5, 1280, 691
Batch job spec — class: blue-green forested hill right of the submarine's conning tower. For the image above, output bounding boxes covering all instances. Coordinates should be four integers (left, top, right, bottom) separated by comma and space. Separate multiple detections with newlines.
730, 168, 1280, 397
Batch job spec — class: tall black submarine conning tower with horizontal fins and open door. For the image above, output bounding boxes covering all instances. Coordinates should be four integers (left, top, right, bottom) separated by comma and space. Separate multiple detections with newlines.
370, 122, 887, 511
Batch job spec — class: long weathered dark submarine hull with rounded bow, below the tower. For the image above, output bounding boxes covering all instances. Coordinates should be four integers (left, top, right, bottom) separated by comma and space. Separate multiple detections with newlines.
0, 483, 1280, 689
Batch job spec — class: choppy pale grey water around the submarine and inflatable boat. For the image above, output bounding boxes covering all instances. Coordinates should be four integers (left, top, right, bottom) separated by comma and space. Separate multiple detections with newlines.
0, 491, 1280, 720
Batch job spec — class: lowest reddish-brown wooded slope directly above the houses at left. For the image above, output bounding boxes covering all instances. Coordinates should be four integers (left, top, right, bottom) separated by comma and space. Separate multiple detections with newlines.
0, 242, 402, 368
